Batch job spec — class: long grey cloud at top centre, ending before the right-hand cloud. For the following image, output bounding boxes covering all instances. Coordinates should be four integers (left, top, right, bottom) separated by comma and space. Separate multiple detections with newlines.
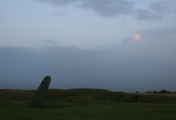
38, 0, 134, 17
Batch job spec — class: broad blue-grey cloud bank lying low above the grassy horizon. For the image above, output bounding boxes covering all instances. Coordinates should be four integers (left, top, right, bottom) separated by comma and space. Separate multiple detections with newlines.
0, 30, 176, 91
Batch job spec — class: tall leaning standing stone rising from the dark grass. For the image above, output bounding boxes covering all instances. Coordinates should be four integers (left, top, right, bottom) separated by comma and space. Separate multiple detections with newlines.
31, 76, 51, 107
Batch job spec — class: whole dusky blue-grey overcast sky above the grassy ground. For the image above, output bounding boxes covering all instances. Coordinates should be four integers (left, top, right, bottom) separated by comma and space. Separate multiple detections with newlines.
0, 0, 176, 91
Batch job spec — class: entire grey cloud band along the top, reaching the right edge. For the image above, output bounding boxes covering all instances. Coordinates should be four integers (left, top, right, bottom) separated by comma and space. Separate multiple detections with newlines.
37, 0, 176, 20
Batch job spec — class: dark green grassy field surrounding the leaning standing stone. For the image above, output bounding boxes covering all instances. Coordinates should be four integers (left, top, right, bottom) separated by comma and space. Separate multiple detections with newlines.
0, 89, 176, 120
